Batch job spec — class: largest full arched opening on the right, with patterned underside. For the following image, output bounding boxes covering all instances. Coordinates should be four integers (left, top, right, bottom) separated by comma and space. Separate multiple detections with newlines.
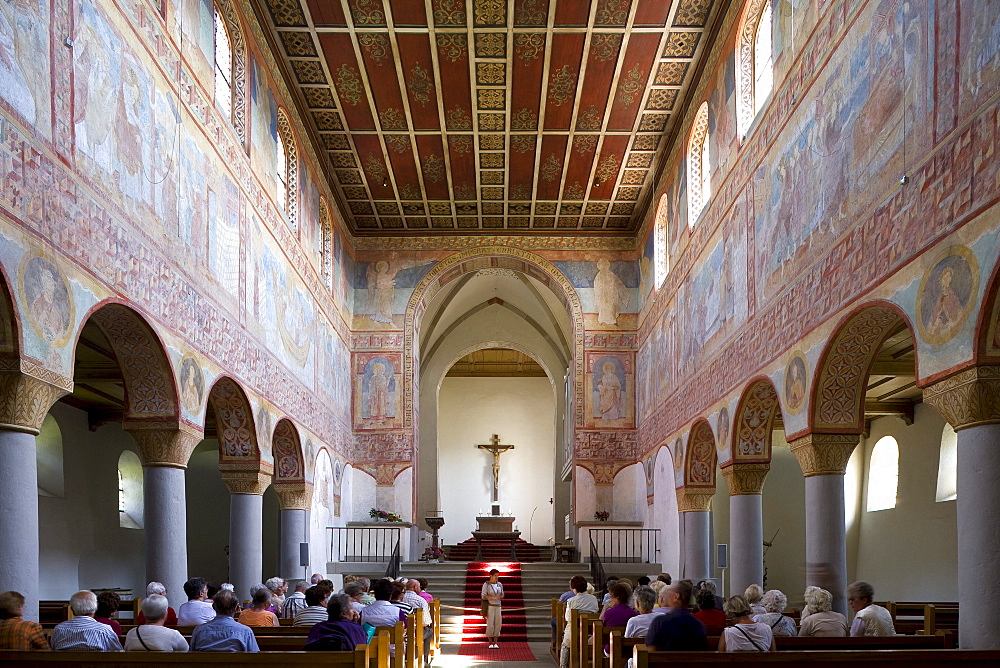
785, 302, 928, 612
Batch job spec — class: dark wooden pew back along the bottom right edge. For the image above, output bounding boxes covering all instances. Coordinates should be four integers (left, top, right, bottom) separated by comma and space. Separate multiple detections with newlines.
633, 645, 1000, 668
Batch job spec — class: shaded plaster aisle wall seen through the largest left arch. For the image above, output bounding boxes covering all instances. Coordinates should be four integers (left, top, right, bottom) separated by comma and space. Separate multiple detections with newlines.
38, 403, 146, 600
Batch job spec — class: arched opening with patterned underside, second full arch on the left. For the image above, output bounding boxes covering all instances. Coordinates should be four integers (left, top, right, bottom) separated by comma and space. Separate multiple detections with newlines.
187, 376, 270, 600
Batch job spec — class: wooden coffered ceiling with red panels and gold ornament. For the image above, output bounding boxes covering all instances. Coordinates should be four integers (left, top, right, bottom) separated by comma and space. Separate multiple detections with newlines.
254, 0, 728, 235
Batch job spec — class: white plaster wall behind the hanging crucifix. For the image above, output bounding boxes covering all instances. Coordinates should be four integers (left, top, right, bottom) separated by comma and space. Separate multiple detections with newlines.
438, 378, 556, 544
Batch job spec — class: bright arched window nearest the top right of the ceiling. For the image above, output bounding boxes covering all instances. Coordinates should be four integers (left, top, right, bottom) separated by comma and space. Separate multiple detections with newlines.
736, 0, 774, 137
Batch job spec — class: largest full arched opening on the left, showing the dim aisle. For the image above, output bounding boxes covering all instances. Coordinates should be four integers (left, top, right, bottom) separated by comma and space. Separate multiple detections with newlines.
39, 302, 186, 598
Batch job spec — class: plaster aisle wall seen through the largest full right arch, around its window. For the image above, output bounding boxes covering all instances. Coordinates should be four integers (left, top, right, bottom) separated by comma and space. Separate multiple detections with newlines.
856, 404, 956, 601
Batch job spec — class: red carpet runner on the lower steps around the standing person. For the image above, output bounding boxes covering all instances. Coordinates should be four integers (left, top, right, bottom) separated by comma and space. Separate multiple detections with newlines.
458, 561, 535, 661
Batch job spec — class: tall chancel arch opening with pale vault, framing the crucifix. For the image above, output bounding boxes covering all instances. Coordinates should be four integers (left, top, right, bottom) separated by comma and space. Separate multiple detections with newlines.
407, 249, 582, 542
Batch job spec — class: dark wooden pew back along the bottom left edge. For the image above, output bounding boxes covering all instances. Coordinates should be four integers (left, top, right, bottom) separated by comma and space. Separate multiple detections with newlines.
0, 645, 374, 668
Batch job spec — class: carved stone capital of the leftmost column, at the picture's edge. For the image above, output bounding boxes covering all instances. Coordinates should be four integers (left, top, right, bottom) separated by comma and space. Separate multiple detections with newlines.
0, 368, 73, 436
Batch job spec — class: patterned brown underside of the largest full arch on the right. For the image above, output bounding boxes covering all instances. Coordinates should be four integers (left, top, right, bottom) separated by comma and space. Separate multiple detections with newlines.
809, 301, 920, 434
